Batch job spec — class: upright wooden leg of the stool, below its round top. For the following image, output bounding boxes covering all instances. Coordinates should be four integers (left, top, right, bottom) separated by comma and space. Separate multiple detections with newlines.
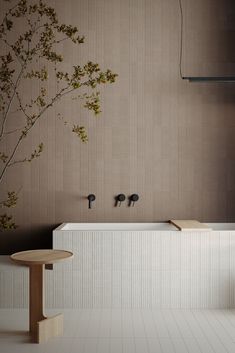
29, 265, 45, 335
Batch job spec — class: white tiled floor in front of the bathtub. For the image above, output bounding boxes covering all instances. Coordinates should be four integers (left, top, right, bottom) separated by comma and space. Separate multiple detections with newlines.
0, 309, 235, 353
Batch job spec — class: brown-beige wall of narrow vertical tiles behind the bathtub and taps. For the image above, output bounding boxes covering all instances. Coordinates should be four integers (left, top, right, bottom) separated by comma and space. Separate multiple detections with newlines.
0, 0, 235, 253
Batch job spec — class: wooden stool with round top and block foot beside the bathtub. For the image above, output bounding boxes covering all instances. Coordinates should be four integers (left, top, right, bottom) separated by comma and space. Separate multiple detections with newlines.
11, 249, 73, 343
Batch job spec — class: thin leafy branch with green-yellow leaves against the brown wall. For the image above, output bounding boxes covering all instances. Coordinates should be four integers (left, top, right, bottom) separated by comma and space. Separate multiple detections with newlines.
0, 0, 117, 230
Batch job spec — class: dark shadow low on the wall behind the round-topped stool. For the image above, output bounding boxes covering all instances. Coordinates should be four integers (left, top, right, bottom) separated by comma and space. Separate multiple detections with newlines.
0, 224, 56, 255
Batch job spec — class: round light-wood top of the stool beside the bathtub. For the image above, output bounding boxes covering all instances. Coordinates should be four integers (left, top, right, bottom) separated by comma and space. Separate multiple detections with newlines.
11, 249, 73, 266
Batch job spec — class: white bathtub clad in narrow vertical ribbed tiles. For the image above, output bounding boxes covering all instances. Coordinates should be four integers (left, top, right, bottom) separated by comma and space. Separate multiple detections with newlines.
51, 223, 235, 308
